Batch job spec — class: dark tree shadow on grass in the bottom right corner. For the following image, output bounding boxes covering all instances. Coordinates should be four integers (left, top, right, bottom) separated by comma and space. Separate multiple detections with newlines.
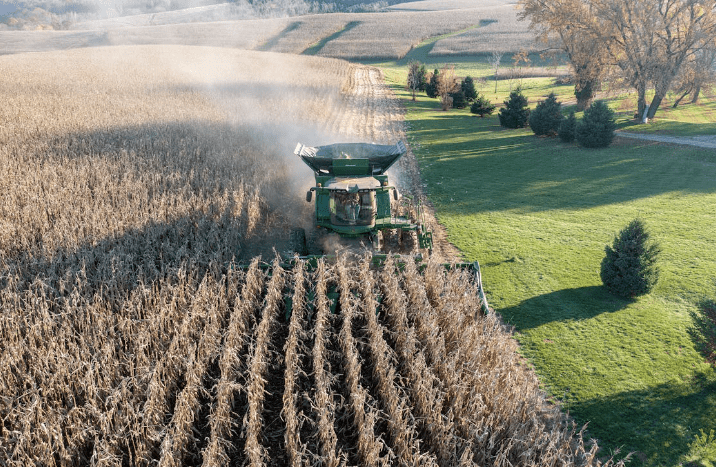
569, 372, 716, 466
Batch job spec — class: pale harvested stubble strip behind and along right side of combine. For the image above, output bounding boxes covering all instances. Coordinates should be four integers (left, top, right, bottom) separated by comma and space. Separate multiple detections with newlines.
329, 65, 461, 261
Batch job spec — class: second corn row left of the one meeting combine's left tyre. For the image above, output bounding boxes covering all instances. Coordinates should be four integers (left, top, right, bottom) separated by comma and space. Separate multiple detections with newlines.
203, 258, 264, 467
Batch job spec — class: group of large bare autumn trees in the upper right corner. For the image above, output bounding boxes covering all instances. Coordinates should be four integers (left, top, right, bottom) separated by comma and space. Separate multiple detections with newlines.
519, 0, 716, 118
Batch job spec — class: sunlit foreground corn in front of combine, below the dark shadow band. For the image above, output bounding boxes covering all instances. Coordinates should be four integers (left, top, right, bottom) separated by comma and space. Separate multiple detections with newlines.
0, 254, 620, 466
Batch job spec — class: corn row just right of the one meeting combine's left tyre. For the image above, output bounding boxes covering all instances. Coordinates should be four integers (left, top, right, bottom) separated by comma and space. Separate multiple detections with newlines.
313, 261, 340, 467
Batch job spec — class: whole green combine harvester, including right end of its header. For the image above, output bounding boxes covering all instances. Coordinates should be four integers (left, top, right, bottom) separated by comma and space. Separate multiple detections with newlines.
285, 141, 489, 313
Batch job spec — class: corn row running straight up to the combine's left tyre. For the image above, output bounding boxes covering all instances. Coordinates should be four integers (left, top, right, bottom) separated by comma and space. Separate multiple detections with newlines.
283, 261, 306, 467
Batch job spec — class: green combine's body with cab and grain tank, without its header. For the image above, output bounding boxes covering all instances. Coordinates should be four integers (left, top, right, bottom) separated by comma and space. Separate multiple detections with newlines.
292, 142, 433, 255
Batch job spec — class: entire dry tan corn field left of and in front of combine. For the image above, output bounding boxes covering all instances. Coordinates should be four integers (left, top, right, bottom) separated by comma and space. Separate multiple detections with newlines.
0, 47, 611, 467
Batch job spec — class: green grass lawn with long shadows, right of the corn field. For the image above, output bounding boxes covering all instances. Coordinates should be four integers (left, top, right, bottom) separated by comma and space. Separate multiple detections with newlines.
382, 59, 716, 466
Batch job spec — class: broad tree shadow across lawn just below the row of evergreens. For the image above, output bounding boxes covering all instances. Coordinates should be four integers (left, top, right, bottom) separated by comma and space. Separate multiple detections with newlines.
412, 113, 716, 215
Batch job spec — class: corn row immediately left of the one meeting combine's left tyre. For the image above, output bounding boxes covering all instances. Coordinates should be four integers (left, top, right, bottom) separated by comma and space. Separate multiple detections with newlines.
244, 259, 284, 467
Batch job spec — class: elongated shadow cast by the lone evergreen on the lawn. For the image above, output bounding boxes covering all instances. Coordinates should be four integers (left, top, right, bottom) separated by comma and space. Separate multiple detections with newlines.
499, 286, 631, 331
